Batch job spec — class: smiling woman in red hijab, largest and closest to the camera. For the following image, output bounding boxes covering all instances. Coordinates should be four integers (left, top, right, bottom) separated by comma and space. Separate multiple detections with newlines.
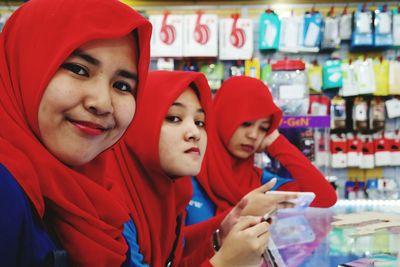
0, 0, 151, 266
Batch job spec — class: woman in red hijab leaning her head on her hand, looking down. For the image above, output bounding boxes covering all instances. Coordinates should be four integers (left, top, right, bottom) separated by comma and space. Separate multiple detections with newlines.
187, 76, 337, 224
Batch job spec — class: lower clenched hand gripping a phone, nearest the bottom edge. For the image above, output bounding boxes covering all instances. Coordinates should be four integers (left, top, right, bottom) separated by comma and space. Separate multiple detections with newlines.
210, 216, 269, 267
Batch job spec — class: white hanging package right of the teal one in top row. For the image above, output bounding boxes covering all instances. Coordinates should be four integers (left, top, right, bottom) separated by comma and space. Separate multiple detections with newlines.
279, 15, 303, 53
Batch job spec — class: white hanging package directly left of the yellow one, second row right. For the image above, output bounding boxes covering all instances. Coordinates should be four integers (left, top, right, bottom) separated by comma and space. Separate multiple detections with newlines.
353, 58, 376, 94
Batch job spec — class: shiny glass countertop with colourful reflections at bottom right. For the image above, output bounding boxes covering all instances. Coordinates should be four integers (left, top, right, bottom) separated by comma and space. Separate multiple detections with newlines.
263, 200, 400, 267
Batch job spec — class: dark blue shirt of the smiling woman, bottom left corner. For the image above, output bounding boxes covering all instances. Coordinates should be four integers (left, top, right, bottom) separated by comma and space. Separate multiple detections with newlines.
0, 164, 66, 267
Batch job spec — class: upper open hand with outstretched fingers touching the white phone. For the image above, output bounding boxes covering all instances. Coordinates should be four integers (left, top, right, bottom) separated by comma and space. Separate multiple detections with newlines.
240, 178, 297, 216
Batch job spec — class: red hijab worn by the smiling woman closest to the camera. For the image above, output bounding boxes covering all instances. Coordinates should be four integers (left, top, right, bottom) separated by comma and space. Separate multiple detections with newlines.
0, 0, 151, 266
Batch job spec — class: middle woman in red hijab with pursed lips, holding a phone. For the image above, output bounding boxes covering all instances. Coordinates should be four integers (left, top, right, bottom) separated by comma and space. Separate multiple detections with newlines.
107, 71, 269, 266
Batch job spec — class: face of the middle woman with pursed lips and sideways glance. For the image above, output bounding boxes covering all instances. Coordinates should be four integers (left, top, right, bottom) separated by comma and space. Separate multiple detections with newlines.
159, 88, 207, 177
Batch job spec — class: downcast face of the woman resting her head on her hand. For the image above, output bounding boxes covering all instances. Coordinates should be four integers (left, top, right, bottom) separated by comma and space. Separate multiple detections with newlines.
228, 117, 272, 159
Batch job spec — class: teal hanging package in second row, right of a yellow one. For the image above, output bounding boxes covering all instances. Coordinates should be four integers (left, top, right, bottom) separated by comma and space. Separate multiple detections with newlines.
322, 59, 342, 90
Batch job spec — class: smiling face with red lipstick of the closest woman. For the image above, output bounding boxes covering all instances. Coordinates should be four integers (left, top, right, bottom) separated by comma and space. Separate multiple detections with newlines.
38, 34, 138, 166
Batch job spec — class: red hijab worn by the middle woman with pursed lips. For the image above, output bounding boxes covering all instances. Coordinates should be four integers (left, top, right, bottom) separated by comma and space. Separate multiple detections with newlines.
109, 71, 211, 266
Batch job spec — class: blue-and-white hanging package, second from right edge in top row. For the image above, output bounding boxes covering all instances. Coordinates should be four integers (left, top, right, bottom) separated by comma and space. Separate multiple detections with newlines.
374, 4, 393, 47
